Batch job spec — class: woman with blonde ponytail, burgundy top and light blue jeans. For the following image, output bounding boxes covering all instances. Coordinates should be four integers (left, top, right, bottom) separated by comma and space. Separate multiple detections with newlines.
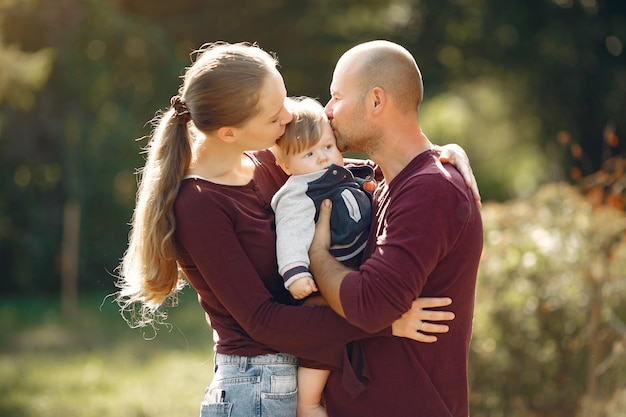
113, 43, 472, 417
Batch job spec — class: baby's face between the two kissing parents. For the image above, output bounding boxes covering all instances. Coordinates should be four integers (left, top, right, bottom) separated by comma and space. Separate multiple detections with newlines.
283, 123, 343, 175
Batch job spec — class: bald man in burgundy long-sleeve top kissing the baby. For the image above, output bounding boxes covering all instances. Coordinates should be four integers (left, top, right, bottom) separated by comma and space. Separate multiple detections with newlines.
309, 41, 483, 417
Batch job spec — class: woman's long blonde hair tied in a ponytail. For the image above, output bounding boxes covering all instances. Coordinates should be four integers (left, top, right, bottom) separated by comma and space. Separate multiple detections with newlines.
116, 43, 278, 327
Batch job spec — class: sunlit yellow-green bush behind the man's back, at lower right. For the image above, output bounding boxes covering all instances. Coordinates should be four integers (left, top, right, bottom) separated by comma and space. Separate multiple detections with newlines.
470, 184, 626, 417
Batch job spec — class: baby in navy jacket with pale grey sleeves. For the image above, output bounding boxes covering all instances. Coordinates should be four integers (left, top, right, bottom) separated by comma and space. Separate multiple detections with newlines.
272, 97, 375, 417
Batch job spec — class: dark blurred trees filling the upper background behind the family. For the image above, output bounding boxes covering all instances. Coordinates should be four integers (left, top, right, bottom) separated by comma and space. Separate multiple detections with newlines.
0, 0, 626, 293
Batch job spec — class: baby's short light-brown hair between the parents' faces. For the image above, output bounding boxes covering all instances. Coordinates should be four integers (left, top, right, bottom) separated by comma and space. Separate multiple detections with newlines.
274, 97, 328, 159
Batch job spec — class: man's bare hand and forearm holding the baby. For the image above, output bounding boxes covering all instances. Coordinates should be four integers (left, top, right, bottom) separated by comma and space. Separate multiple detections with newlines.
309, 200, 351, 318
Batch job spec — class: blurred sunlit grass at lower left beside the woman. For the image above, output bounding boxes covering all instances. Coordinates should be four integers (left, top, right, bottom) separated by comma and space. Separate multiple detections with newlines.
0, 289, 212, 417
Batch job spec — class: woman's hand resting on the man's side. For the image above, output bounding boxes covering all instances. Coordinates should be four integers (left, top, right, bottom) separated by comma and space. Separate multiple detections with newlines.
391, 297, 454, 343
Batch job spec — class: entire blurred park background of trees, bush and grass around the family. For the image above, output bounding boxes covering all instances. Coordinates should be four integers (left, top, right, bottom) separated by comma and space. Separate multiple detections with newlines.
0, 0, 626, 417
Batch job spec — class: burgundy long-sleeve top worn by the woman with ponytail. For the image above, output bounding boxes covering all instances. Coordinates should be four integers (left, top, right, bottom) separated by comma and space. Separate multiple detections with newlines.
175, 151, 378, 367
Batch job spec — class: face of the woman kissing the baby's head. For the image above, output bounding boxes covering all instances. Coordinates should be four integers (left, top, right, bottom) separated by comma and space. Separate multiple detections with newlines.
237, 69, 293, 151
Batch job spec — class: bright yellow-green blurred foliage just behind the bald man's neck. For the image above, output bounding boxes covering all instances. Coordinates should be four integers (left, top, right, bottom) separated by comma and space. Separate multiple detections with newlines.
420, 78, 559, 200
